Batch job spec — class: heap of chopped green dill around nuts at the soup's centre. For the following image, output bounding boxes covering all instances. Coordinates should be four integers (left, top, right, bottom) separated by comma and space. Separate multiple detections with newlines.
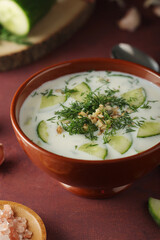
55, 88, 144, 143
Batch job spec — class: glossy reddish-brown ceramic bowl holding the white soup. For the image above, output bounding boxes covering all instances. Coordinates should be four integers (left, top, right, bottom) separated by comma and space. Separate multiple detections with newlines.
11, 58, 160, 198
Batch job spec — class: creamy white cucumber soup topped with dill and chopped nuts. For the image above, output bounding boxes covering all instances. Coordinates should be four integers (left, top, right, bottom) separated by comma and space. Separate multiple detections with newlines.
20, 71, 160, 160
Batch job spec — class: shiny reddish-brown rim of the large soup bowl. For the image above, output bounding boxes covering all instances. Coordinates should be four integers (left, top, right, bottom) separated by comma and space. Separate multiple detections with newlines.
10, 57, 160, 164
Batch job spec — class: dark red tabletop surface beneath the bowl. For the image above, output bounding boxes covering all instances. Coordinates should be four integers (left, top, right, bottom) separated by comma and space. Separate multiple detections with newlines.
0, 0, 160, 240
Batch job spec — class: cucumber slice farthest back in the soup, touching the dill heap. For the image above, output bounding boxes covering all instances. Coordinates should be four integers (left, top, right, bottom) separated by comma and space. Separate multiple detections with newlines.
70, 82, 91, 102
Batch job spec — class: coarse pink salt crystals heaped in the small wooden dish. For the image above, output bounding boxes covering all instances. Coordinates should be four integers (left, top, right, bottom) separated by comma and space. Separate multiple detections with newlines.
0, 204, 32, 240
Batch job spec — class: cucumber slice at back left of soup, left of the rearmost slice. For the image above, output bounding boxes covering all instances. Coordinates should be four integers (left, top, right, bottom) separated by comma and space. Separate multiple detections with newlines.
40, 95, 66, 108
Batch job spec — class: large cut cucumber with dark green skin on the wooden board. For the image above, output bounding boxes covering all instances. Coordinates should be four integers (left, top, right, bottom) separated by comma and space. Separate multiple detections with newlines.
0, 0, 55, 35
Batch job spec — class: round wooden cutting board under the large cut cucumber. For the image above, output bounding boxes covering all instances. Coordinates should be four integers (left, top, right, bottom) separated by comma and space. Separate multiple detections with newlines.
0, 0, 94, 71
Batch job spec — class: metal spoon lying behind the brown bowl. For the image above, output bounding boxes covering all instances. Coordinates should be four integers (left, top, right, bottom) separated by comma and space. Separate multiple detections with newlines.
111, 43, 160, 72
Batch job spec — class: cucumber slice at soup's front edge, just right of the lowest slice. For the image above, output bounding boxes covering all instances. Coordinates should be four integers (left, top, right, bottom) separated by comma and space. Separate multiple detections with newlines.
108, 136, 132, 154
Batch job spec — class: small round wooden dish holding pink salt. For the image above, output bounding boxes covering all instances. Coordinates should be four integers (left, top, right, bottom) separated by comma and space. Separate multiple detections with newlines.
0, 200, 47, 240
